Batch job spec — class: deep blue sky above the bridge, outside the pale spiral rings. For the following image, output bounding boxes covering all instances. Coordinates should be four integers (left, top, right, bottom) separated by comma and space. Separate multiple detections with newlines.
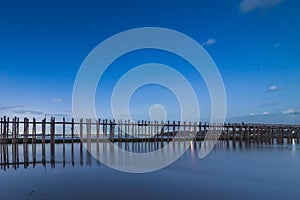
0, 0, 300, 123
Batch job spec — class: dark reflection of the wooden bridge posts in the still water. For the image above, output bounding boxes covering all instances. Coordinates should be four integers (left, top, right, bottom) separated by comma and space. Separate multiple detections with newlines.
0, 141, 200, 170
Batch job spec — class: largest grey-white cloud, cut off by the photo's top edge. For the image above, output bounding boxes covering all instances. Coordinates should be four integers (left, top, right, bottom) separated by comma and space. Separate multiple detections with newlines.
240, 0, 283, 13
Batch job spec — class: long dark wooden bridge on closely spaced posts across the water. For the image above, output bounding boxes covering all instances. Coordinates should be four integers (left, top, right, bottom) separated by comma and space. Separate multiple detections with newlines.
0, 116, 300, 144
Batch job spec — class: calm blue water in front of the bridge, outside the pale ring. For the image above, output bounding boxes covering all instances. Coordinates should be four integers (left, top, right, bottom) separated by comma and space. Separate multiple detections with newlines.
0, 142, 300, 200
